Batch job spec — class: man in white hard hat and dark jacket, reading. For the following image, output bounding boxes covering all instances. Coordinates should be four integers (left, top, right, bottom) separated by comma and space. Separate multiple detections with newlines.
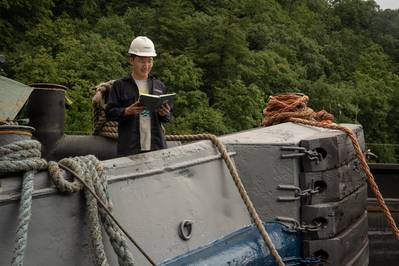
106, 36, 171, 156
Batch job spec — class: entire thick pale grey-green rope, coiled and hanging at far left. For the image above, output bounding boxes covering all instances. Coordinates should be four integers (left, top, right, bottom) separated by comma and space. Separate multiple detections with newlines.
0, 140, 141, 266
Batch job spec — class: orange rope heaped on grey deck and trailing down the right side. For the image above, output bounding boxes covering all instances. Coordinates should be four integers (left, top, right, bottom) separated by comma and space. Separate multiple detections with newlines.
262, 93, 399, 239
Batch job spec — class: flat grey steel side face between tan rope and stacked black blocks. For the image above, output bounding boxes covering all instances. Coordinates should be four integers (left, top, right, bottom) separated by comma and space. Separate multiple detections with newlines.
228, 143, 300, 221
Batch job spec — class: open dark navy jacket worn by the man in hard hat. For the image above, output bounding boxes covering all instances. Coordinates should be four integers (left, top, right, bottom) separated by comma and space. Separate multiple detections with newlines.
105, 76, 170, 156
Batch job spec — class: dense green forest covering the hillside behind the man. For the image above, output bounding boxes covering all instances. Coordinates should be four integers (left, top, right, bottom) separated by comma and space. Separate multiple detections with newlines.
0, 0, 399, 162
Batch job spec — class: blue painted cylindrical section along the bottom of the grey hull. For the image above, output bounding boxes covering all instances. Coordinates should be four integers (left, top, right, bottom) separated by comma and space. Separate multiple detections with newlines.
160, 222, 301, 266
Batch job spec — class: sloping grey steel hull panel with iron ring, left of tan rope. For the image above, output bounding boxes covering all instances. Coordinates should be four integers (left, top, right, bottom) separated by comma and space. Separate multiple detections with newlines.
0, 141, 251, 265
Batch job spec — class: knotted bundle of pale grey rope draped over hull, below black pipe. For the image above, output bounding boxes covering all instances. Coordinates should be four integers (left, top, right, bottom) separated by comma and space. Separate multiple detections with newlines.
48, 155, 134, 265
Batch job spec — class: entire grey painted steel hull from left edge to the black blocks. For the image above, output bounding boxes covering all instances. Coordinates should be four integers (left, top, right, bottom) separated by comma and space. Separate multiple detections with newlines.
0, 123, 364, 265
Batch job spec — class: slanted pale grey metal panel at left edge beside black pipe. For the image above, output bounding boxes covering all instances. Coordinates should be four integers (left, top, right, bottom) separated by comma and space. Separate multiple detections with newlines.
0, 76, 33, 120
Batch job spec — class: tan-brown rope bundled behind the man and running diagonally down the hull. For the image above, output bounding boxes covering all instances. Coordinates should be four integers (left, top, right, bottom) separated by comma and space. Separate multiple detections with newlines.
93, 81, 285, 266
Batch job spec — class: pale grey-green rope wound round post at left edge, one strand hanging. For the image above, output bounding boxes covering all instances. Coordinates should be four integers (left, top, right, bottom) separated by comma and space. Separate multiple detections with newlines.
0, 140, 47, 266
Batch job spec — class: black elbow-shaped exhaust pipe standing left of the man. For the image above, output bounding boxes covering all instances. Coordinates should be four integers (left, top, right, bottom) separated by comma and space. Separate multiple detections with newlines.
28, 83, 117, 161
